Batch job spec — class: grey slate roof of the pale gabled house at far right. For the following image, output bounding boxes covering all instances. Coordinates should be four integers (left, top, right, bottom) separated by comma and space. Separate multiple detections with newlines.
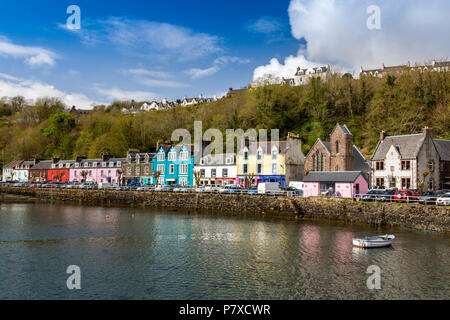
372, 133, 424, 160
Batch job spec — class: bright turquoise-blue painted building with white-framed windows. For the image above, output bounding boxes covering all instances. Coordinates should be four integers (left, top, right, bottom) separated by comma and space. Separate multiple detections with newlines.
152, 144, 194, 186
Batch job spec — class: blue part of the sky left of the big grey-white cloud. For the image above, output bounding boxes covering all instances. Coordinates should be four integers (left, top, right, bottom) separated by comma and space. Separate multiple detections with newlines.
0, 0, 301, 107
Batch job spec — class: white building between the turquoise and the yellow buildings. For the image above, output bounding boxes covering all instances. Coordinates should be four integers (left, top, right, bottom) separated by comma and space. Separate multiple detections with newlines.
194, 154, 237, 186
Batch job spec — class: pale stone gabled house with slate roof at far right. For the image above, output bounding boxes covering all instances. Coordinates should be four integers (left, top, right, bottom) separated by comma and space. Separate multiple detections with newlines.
371, 127, 450, 191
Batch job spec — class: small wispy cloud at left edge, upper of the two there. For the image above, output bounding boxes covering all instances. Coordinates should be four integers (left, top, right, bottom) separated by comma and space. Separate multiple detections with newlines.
0, 36, 58, 67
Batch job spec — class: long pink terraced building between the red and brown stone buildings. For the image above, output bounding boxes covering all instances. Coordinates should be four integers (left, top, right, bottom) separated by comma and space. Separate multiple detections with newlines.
69, 156, 126, 184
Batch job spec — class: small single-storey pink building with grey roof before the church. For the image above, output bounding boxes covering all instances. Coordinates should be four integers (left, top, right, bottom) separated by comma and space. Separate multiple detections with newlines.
303, 171, 369, 198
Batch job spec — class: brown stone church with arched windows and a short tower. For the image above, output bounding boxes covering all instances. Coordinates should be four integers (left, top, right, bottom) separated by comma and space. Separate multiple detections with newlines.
304, 123, 371, 178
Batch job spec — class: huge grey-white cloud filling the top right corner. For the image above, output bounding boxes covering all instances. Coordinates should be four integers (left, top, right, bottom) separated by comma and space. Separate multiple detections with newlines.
255, 0, 450, 76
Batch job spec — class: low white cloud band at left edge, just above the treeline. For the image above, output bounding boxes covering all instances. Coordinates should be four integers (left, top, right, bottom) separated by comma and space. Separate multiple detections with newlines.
0, 74, 99, 109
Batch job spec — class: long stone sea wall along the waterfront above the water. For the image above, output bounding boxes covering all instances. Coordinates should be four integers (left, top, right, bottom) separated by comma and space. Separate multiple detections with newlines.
0, 186, 450, 233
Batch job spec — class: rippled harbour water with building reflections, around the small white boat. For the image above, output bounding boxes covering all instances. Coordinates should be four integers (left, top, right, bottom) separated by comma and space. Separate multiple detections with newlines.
0, 203, 450, 300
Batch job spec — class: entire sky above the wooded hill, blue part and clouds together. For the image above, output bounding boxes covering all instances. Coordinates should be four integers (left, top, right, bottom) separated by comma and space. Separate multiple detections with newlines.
0, 0, 450, 108
